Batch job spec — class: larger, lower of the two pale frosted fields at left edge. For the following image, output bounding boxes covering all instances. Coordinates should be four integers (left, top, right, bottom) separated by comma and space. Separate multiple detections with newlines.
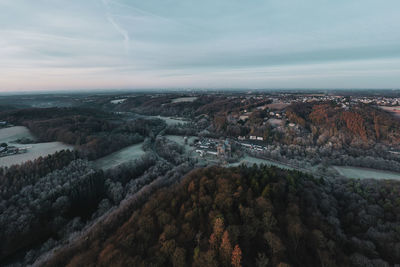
0, 142, 73, 167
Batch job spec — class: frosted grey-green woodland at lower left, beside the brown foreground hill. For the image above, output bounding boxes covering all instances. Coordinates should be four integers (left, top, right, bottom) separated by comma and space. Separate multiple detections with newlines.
0, 121, 194, 266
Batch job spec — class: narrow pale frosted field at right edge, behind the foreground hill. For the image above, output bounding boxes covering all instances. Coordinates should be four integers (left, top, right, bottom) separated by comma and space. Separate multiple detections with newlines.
333, 166, 400, 180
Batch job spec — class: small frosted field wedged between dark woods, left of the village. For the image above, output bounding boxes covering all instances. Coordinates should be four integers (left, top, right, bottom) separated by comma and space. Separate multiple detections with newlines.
94, 143, 146, 170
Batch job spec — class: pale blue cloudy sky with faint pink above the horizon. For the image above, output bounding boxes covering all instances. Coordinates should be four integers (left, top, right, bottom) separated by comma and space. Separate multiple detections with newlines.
0, 0, 400, 92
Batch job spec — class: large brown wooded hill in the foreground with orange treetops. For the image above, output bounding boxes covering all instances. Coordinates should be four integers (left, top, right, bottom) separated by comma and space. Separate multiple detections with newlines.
41, 166, 400, 266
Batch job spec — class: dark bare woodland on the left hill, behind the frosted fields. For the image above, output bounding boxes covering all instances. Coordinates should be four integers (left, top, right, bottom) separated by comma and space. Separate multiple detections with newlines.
0, 108, 165, 160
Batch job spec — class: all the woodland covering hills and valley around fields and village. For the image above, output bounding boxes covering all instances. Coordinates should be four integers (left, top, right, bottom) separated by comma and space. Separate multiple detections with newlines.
0, 94, 400, 267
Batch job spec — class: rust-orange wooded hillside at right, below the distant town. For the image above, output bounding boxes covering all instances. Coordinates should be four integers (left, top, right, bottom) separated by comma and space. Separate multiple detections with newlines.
286, 102, 400, 149
